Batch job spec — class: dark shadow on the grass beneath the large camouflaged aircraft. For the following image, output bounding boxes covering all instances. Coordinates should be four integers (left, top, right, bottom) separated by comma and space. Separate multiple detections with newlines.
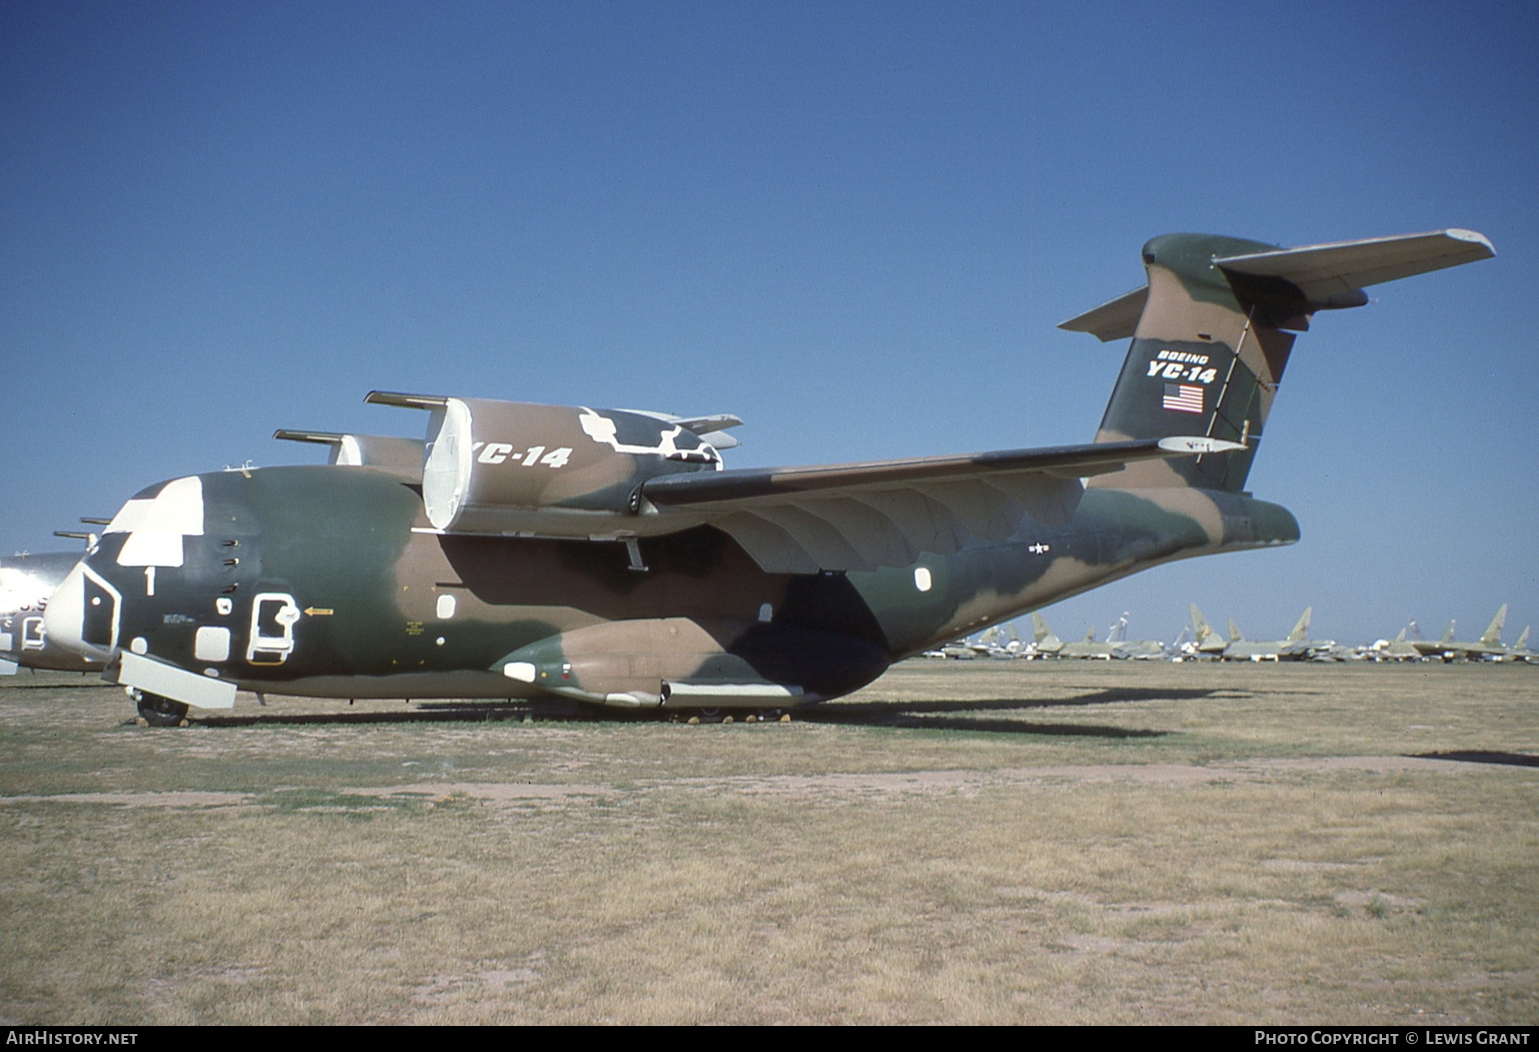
171, 687, 1233, 738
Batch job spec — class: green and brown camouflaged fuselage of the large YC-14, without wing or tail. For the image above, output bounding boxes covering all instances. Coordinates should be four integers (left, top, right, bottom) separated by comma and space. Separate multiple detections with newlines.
56, 466, 1297, 704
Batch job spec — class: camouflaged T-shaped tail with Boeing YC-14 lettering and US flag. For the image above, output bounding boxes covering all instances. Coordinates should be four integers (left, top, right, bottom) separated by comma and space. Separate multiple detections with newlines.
1059, 231, 1494, 492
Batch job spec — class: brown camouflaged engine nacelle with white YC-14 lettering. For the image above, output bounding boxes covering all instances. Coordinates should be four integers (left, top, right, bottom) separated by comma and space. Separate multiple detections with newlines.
368, 392, 722, 538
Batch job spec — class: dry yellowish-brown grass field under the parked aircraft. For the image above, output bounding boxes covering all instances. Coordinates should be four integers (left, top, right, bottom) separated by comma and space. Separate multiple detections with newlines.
0, 661, 1539, 1024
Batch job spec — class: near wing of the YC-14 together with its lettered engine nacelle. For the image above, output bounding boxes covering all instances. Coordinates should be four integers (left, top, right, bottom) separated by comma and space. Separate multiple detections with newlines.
378, 392, 1244, 574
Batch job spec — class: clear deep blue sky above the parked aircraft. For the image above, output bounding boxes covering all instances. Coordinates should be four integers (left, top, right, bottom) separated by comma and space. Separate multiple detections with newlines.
0, 0, 1539, 641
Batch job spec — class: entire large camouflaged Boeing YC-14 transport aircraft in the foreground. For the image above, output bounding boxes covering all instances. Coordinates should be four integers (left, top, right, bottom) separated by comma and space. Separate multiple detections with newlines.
48, 231, 1493, 723
